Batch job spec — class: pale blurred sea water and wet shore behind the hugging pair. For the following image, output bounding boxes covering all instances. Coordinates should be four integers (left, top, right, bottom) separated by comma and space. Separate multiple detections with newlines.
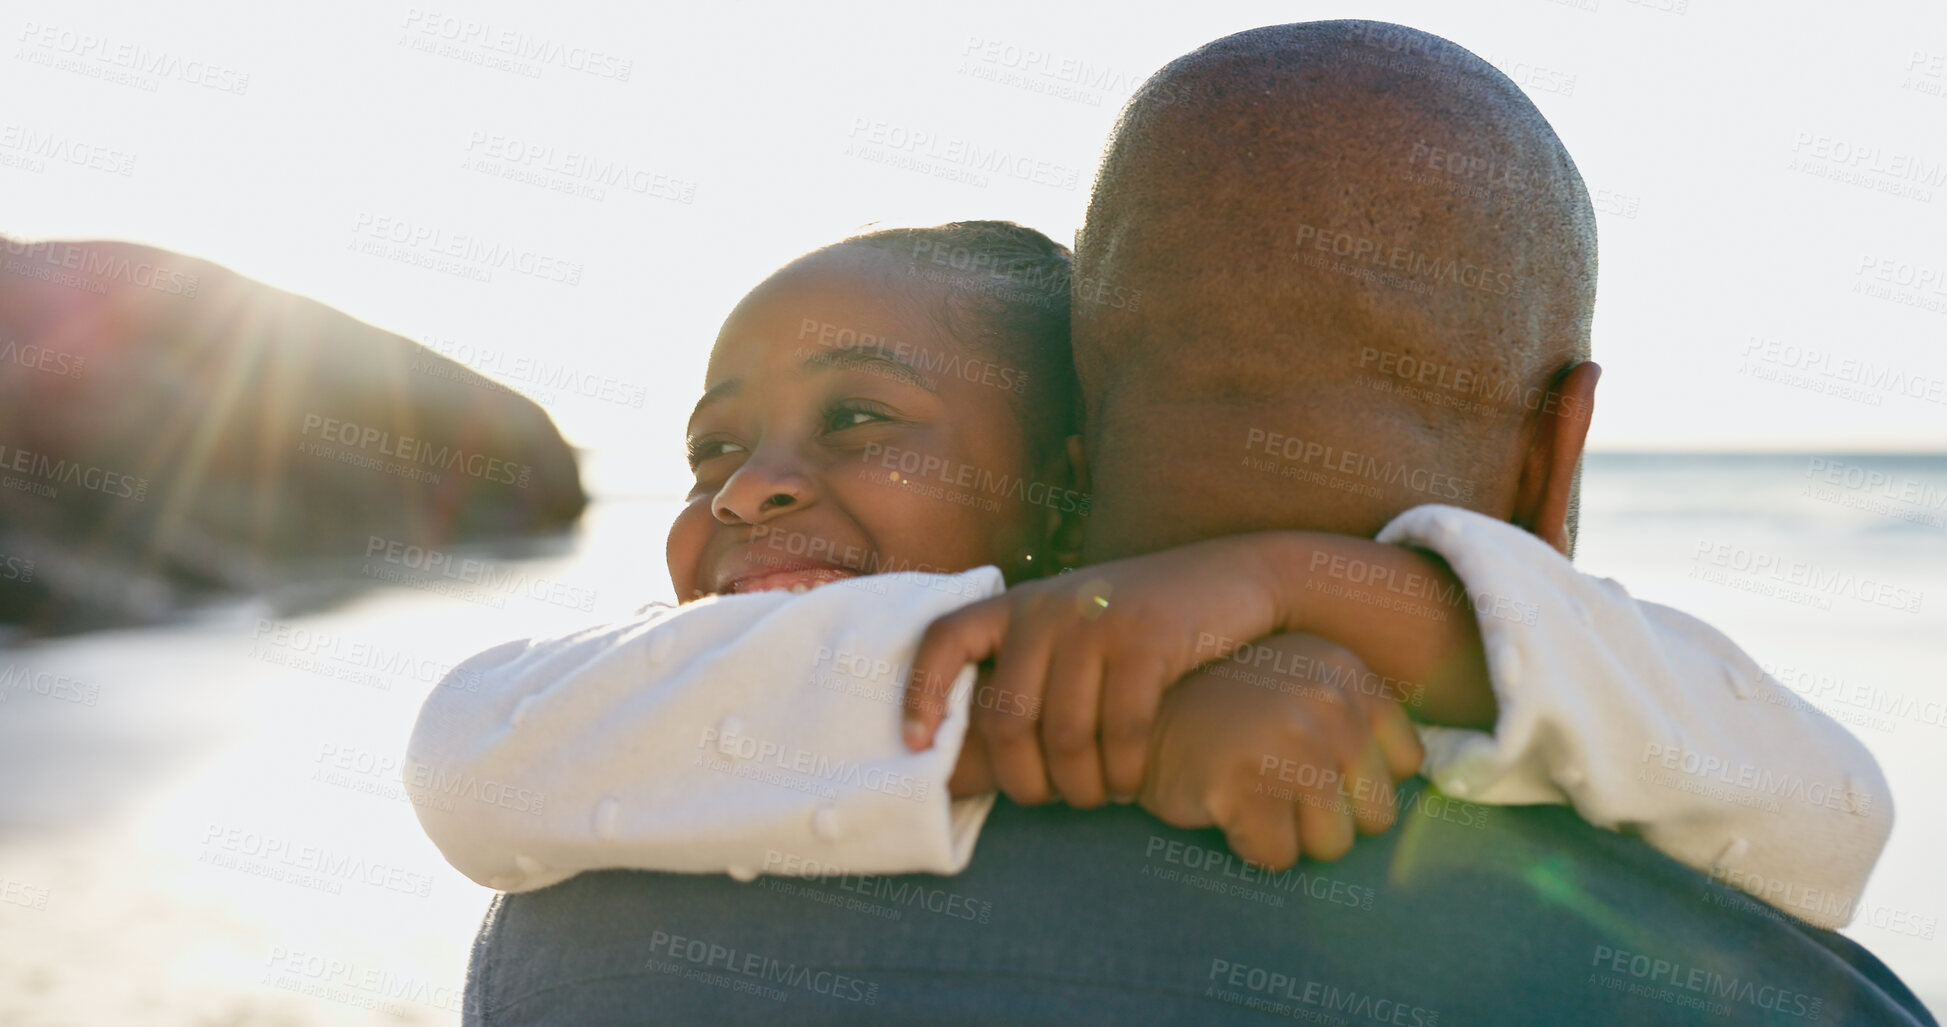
0, 454, 1947, 1025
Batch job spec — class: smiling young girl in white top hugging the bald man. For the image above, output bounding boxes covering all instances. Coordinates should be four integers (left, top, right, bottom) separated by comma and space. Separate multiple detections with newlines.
405, 222, 1891, 926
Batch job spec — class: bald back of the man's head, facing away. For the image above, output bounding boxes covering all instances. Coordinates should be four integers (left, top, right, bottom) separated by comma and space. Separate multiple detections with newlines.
1075, 21, 1595, 557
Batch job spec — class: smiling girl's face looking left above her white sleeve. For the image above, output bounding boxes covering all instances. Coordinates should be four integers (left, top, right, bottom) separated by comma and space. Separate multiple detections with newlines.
668, 246, 1073, 602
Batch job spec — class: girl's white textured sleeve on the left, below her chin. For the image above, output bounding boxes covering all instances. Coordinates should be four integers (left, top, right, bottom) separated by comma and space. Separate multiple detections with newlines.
405, 567, 1001, 891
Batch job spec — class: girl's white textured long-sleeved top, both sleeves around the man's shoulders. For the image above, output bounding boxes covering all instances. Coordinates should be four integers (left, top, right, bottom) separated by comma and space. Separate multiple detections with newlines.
405, 507, 1892, 928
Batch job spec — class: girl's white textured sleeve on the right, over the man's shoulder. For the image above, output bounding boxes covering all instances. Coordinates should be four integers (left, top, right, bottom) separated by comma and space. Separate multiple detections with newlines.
1349, 507, 1892, 930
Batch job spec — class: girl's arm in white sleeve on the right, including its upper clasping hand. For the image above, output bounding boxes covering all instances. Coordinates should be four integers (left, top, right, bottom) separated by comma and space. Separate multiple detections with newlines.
907, 507, 1892, 928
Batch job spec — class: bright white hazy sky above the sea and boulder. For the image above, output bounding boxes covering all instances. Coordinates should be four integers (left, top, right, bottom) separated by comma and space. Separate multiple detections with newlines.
0, 0, 1947, 493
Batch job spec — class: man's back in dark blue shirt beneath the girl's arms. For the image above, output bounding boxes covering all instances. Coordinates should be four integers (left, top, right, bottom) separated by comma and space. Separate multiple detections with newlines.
455, 780, 1933, 1027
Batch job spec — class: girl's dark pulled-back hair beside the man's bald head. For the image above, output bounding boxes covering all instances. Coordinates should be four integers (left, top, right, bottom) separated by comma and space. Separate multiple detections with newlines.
839, 220, 1081, 448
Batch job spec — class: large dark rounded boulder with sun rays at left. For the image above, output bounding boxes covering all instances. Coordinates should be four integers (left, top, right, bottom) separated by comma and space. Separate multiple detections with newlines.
0, 238, 586, 631
